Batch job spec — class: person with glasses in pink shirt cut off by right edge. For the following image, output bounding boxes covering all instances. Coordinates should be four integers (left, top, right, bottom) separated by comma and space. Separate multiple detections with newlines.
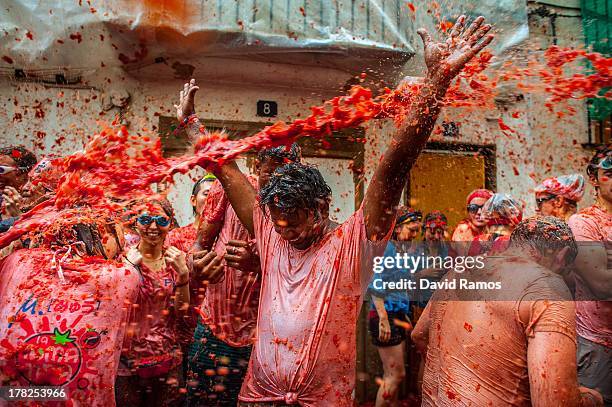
568, 145, 612, 406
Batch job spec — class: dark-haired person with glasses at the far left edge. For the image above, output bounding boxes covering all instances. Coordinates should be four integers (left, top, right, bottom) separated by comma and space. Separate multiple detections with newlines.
0, 146, 37, 233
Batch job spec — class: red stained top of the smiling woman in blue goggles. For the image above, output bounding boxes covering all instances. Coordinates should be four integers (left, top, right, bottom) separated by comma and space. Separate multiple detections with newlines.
119, 247, 180, 376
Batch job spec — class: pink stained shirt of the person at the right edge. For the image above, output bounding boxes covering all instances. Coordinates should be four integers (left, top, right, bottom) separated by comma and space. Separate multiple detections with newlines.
568, 205, 612, 348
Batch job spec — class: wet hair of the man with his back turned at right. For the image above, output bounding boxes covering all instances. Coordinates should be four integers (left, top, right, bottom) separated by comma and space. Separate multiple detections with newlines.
510, 215, 578, 264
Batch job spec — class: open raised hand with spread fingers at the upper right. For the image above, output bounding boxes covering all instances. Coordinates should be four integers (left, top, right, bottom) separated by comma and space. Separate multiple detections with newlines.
417, 16, 493, 85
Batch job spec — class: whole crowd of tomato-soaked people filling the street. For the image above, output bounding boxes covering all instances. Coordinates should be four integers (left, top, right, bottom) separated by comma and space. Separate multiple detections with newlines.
0, 17, 612, 407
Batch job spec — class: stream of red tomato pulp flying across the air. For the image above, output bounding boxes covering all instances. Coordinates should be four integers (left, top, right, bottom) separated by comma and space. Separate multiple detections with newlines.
0, 47, 612, 252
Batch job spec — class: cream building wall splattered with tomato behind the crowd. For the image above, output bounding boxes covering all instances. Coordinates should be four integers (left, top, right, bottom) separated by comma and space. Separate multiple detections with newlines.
0, 2, 590, 223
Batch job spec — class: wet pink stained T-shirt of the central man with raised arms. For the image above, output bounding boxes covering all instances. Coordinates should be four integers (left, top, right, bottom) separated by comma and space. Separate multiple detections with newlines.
239, 206, 393, 406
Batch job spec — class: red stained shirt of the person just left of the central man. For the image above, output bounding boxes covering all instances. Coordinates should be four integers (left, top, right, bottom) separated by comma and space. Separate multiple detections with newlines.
200, 177, 261, 347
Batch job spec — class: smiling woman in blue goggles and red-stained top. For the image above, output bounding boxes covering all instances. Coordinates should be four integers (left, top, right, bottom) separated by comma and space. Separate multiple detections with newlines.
115, 199, 196, 406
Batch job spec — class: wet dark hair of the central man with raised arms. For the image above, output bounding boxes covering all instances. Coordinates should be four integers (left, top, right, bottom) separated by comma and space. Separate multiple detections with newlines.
259, 163, 331, 213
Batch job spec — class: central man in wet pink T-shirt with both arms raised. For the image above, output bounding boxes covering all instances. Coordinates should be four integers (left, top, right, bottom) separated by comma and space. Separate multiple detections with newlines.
179, 16, 493, 406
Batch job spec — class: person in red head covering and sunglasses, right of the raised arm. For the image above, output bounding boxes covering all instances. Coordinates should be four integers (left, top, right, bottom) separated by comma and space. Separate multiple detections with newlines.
451, 189, 493, 256
